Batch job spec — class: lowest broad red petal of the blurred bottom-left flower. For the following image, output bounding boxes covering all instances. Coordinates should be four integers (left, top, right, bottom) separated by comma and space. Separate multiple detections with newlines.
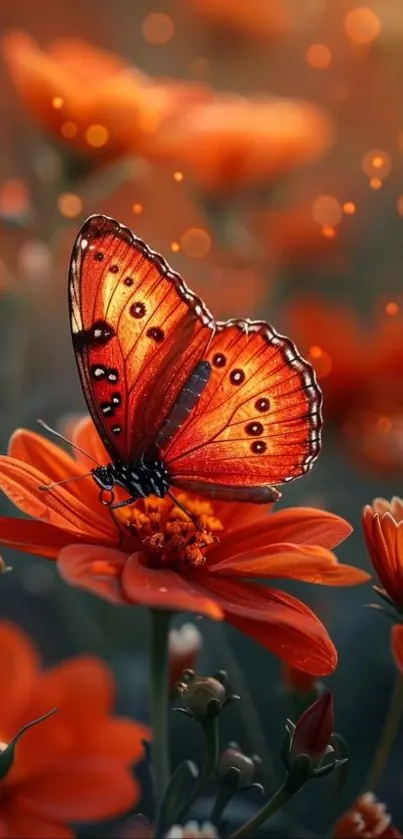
16, 755, 140, 822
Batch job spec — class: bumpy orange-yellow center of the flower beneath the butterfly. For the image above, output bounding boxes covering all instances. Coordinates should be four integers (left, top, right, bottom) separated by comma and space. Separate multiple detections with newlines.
116, 494, 223, 572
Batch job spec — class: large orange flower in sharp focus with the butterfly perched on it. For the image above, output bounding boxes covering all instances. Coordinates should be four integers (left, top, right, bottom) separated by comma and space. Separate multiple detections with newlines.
0, 420, 368, 675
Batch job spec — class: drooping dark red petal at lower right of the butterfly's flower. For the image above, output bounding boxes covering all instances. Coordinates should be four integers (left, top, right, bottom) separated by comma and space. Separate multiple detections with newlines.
195, 576, 337, 676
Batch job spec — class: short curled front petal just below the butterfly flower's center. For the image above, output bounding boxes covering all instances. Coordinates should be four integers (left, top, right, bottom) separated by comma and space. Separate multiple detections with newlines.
122, 553, 223, 620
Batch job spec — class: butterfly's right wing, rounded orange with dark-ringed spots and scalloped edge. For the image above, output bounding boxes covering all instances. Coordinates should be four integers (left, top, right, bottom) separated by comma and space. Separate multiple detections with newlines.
161, 321, 322, 501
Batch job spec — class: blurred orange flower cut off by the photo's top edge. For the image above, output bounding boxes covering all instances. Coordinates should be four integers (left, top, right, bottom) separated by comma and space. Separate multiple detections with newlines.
185, 0, 289, 40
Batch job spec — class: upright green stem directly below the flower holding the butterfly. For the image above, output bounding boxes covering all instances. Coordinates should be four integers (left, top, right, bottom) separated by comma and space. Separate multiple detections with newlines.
150, 609, 171, 804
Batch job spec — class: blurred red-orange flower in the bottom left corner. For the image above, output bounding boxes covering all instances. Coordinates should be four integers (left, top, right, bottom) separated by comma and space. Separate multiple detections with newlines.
0, 621, 150, 839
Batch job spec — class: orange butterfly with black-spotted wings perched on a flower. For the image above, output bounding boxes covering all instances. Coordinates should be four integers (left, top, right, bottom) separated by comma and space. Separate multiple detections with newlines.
69, 215, 322, 507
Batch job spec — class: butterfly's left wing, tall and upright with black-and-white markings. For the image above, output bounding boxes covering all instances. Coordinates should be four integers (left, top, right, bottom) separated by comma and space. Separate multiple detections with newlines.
69, 215, 215, 461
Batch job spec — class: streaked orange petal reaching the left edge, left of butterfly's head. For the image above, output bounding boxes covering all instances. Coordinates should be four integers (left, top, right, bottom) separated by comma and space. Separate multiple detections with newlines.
0, 456, 117, 542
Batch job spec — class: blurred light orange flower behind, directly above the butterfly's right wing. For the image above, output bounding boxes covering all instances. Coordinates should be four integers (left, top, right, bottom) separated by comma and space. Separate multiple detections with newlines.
153, 95, 332, 194
